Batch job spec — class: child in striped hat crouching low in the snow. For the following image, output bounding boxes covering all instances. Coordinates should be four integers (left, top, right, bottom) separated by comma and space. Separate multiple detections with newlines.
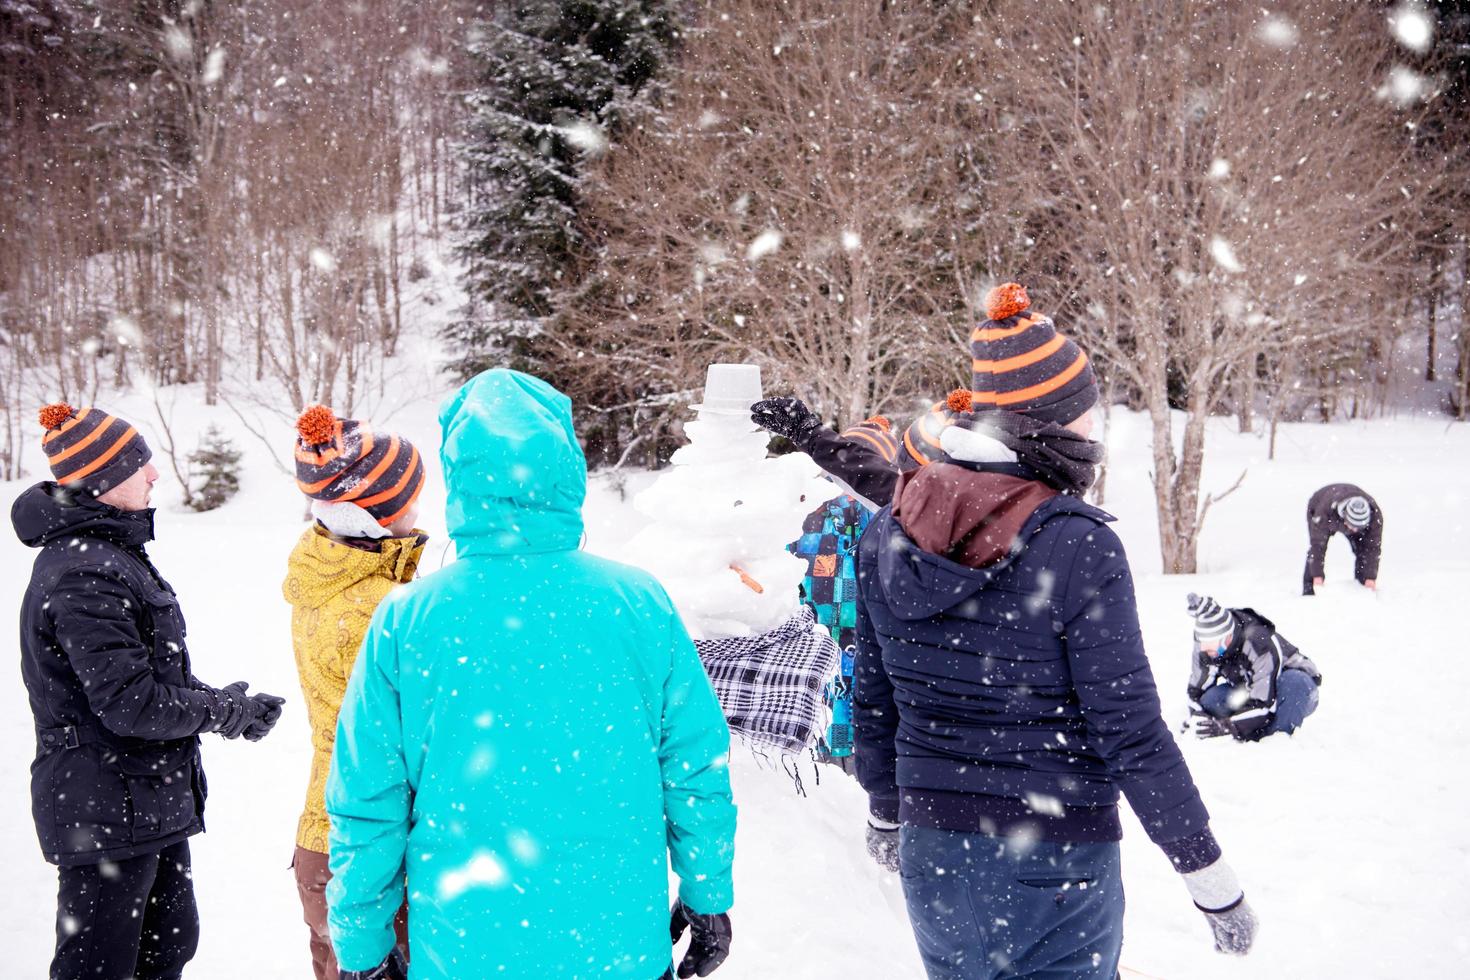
1185, 592, 1322, 742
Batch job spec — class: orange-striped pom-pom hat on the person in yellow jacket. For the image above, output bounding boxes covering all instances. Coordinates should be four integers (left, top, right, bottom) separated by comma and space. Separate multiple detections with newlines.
295, 406, 425, 527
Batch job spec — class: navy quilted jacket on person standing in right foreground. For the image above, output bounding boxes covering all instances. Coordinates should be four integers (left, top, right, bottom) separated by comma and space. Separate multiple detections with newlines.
854, 463, 1214, 848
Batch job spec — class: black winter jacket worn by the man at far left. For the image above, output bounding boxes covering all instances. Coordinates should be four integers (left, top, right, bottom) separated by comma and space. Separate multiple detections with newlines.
10, 483, 228, 865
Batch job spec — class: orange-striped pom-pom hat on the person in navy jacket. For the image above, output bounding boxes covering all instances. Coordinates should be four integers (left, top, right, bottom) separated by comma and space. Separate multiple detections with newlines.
970, 282, 1098, 425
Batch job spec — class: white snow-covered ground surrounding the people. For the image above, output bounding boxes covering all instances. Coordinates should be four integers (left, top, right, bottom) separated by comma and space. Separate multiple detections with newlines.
0, 397, 1470, 980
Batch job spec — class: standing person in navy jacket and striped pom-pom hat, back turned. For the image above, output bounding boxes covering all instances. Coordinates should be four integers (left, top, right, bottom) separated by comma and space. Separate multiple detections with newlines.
854, 284, 1255, 980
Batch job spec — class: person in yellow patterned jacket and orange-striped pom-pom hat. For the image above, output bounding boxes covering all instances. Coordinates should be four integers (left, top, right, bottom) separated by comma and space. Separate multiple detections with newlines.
284, 406, 426, 980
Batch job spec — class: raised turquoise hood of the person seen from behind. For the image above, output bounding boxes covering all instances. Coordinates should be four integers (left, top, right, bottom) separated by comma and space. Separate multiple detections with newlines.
440, 367, 587, 555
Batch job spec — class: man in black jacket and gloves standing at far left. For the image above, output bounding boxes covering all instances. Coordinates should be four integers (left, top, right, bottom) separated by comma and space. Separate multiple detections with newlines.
10, 404, 284, 980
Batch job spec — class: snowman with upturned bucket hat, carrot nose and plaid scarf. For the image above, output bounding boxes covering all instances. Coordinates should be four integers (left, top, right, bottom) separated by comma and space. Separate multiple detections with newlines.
625, 364, 839, 754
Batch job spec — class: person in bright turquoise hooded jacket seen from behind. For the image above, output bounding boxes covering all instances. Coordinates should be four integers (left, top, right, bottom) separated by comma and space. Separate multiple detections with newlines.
326, 369, 735, 980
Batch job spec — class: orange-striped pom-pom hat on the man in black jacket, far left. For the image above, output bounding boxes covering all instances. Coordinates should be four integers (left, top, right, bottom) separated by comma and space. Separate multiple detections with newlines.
41, 401, 153, 497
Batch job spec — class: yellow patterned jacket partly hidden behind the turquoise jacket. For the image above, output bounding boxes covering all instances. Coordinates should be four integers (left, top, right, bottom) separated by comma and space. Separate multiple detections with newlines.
282, 526, 428, 854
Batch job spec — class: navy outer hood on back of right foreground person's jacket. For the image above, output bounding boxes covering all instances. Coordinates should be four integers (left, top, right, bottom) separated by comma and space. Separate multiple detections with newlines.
869, 495, 1113, 620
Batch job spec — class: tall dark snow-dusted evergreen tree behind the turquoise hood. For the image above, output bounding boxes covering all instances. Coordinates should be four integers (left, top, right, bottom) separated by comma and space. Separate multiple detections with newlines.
445, 0, 678, 378
